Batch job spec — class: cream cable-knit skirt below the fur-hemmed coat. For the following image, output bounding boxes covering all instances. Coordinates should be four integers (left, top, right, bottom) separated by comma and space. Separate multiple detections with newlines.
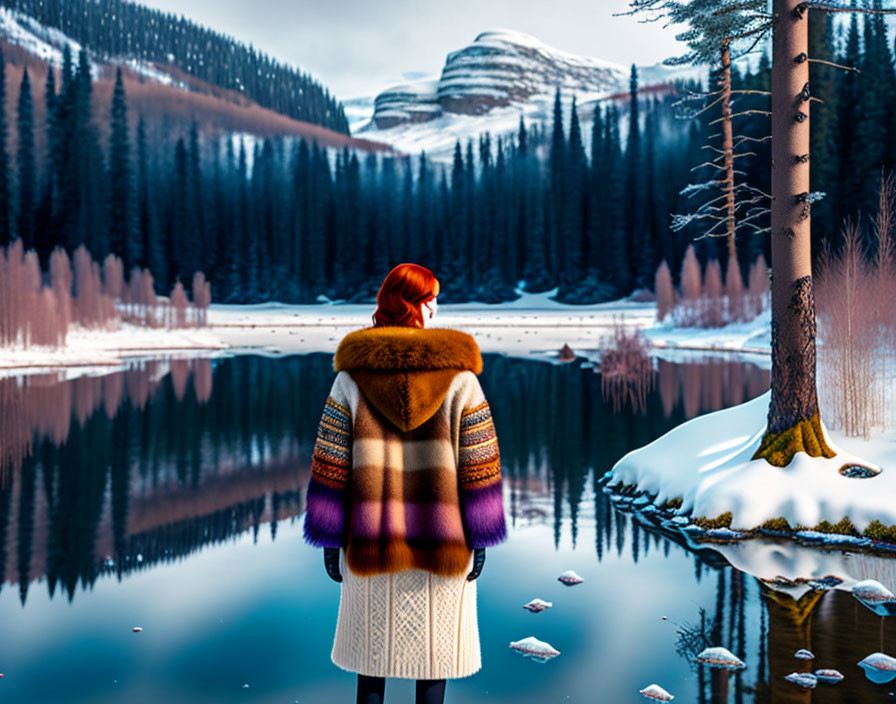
332, 551, 482, 680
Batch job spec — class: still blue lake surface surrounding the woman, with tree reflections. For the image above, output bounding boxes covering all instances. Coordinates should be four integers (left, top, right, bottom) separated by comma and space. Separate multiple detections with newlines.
0, 354, 896, 704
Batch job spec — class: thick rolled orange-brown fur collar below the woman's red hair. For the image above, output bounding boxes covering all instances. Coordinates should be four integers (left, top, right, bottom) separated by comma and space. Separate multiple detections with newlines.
333, 327, 482, 374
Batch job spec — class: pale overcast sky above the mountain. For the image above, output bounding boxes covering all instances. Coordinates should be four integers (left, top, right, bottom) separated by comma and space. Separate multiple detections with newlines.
141, 0, 680, 100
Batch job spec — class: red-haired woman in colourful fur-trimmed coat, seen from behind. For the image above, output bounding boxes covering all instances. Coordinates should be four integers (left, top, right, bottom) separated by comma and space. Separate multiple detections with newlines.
304, 264, 507, 704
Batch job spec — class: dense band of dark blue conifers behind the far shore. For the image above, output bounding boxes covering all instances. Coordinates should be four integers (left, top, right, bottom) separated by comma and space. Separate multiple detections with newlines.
0, 11, 896, 303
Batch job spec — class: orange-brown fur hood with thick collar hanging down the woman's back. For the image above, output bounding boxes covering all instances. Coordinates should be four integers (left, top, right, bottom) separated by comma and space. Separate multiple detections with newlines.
333, 327, 482, 432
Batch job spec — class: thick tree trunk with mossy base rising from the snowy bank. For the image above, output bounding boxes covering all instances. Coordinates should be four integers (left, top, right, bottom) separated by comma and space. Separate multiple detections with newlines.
754, 0, 834, 467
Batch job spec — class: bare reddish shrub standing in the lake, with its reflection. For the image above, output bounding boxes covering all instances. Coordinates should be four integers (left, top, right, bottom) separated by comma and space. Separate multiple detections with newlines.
600, 320, 656, 412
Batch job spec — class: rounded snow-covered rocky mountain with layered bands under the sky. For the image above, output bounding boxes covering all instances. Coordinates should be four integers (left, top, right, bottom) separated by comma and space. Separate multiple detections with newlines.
352, 29, 702, 159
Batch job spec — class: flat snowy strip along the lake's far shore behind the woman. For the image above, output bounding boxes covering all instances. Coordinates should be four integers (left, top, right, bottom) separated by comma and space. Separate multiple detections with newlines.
0, 292, 769, 375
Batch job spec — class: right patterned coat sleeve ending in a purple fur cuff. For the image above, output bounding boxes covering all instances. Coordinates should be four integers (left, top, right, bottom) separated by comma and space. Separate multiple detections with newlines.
458, 401, 507, 548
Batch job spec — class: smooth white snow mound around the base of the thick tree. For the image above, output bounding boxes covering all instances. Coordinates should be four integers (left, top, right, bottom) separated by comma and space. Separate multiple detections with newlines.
610, 393, 896, 532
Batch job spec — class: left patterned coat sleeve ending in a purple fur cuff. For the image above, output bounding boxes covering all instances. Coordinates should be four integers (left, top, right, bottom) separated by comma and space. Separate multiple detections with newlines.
304, 396, 352, 548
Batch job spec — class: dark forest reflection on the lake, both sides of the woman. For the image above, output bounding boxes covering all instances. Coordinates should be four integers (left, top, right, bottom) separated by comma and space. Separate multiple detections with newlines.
0, 355, 767, 602
